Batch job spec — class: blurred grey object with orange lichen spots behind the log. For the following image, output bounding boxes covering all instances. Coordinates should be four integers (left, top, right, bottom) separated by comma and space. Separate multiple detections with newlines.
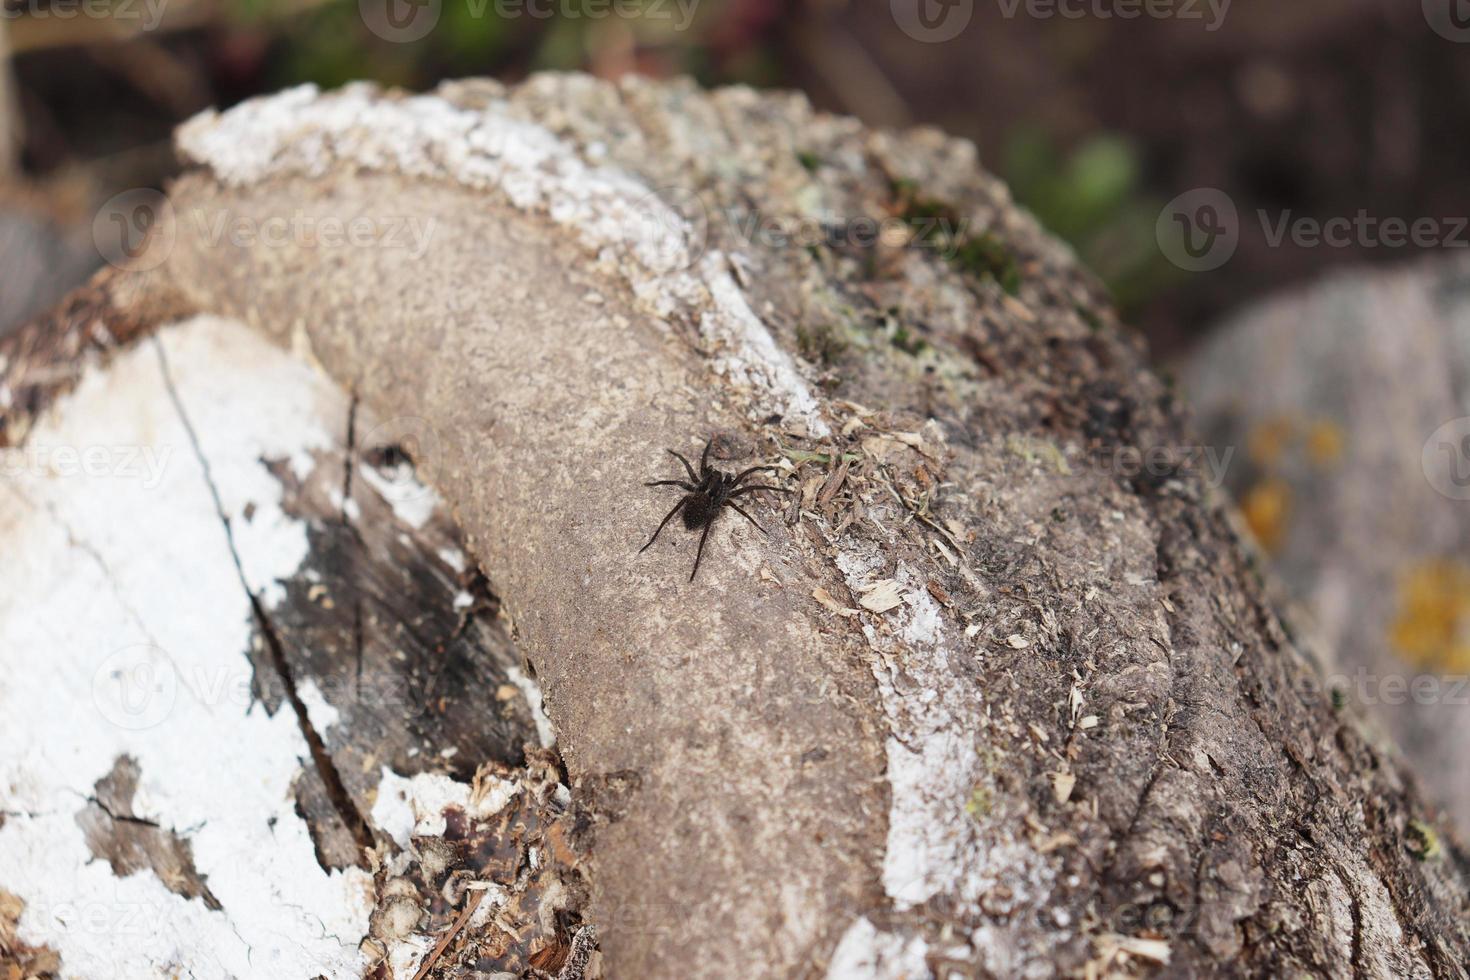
1183, 260, 1470, 833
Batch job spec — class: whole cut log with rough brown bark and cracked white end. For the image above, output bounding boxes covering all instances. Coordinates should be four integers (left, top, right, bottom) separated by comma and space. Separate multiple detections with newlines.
0, 76, 1470, 979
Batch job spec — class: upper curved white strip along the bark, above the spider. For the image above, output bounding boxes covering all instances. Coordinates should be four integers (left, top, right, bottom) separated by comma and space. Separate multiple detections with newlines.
178, 85, 831, 438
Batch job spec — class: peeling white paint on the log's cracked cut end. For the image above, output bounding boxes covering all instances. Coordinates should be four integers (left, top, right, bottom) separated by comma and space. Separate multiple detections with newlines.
0, 317, 372, 980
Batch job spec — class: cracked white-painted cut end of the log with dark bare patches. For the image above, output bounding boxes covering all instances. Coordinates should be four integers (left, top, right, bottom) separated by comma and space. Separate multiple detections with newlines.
0, 302, 585, 977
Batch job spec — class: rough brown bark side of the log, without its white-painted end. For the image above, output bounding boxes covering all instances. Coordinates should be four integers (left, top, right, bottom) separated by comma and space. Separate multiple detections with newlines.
0, 76, 1470, 977
